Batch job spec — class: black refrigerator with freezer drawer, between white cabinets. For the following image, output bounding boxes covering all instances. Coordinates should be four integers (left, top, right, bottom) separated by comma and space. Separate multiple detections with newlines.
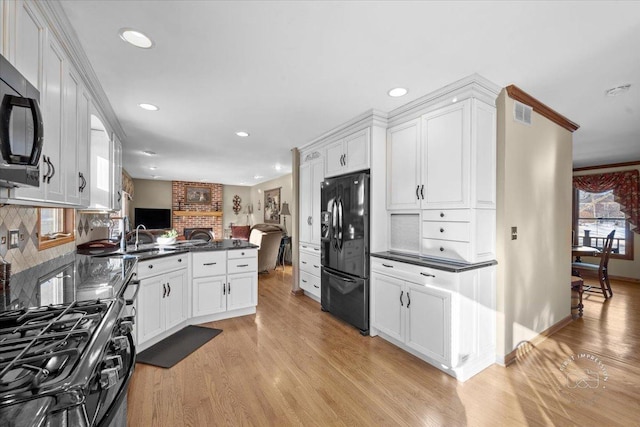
320, 171, 369, 335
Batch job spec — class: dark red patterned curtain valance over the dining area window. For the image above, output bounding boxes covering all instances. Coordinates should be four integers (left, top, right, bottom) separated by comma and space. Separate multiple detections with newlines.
573, 170, 640, 233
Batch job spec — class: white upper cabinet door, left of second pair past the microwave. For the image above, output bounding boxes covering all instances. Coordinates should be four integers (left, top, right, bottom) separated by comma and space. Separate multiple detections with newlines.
61, 64, 82, 205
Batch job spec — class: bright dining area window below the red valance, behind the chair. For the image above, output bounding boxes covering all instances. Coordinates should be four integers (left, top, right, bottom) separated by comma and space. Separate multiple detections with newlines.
573, 190, 633, 259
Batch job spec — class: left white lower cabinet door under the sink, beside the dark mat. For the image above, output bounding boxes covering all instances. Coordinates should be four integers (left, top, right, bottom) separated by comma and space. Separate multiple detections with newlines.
136, 277, 166, 343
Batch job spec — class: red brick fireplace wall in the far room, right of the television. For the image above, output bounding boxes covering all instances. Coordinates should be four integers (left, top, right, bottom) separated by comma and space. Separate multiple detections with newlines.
171, 181, 223, 239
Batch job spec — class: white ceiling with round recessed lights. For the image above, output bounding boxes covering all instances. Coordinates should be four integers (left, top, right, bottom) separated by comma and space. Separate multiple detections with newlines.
61, 0, 640, 185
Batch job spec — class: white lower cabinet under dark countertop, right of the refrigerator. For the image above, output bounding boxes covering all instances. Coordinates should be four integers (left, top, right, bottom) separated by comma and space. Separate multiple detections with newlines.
370, 258, 495, 381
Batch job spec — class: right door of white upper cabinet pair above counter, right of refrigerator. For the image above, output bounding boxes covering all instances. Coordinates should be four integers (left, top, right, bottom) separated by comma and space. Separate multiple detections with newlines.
422, 100, 471, 209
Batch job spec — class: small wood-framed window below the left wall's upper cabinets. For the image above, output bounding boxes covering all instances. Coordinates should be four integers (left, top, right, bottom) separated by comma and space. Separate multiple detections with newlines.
38, 208, 75, 250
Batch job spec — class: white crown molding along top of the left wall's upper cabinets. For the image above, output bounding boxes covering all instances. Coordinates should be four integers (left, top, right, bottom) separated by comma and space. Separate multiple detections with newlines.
32, 0, 126, 141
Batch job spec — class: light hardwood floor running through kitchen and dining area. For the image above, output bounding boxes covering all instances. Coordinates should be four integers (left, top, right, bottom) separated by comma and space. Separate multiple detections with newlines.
128, 267, 640, 426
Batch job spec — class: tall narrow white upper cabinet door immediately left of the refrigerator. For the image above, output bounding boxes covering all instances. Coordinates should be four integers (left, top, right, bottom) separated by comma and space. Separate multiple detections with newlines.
299, 154, 324, 245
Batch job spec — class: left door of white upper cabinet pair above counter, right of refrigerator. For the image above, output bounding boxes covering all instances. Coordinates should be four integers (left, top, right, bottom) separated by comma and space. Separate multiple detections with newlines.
387, 119, 424, 209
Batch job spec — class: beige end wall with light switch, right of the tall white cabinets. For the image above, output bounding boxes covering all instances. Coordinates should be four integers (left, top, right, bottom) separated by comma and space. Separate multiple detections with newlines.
496, 90, 572, 362
